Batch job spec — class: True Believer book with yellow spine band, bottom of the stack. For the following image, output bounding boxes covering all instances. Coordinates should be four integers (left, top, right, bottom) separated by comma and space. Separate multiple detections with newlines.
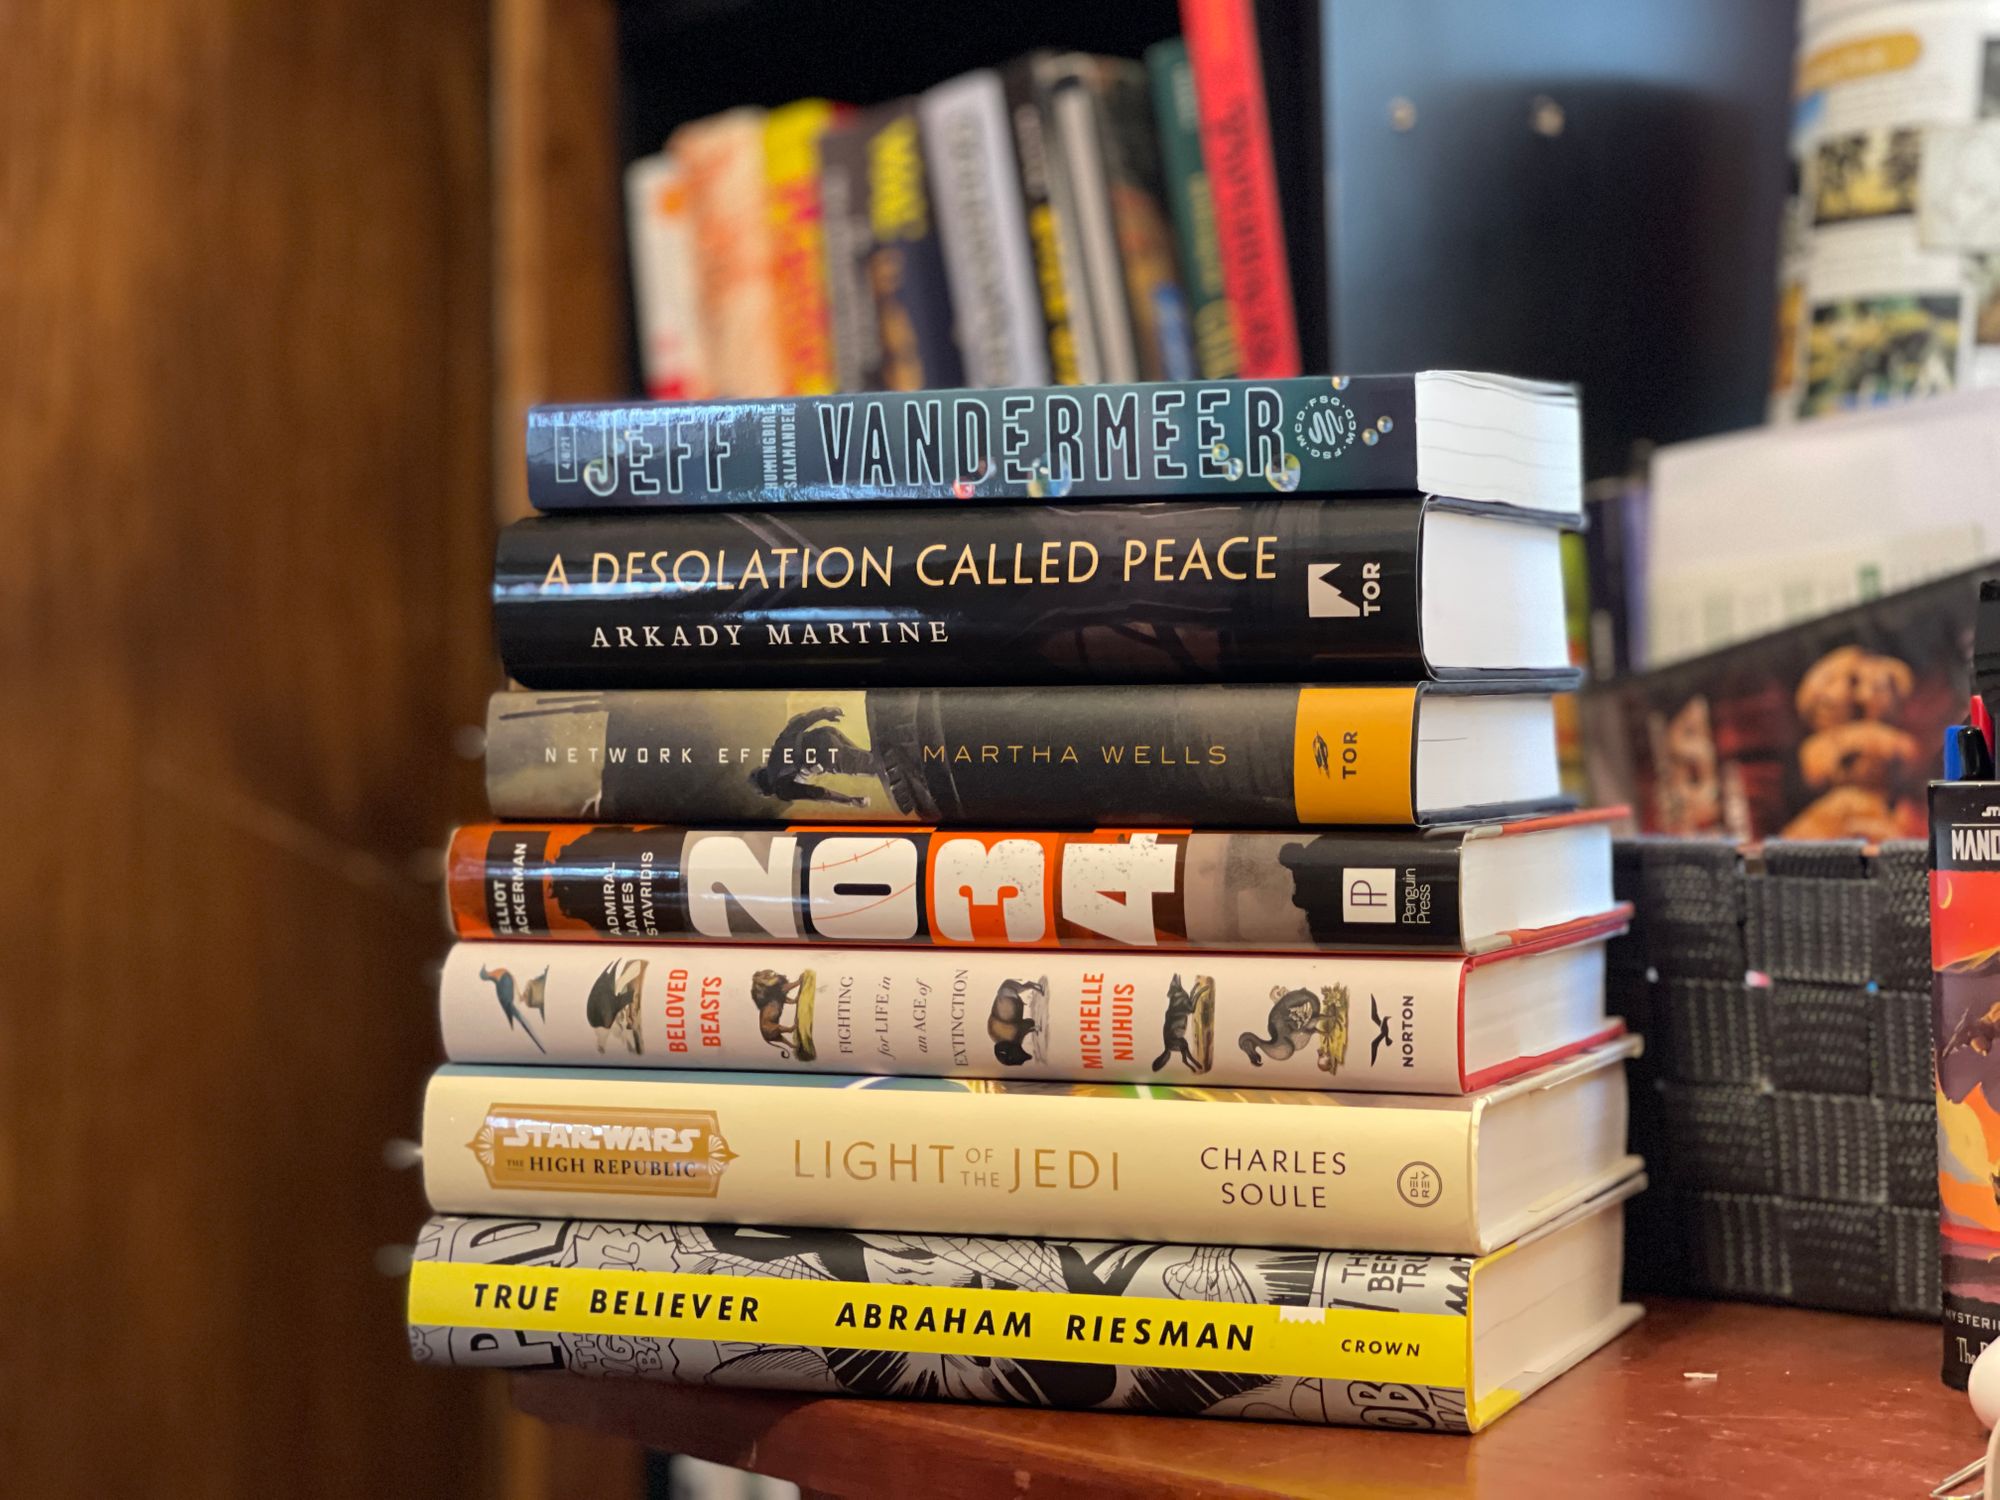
408, 1176, 1644, 1432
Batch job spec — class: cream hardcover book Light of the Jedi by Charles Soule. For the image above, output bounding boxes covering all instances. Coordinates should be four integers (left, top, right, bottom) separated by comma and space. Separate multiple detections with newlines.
422, 1038, 1638, 1254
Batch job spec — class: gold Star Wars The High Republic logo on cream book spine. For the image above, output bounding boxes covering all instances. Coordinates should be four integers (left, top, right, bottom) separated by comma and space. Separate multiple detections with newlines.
466, 1104, 736, 1198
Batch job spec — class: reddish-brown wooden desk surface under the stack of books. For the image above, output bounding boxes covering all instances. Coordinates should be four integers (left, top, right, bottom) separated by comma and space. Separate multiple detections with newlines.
514, 1300, 1984, 1500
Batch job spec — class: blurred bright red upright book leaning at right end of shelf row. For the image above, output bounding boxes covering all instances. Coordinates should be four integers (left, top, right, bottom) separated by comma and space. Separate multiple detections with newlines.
1180, 0, 1300, 376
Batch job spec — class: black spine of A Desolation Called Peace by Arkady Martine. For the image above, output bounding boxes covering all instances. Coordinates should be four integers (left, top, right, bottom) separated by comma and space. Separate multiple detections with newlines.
494, 498, 1440, 688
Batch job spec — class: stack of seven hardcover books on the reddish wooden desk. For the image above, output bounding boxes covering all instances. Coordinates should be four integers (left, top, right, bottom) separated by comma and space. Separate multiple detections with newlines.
410, 372, 1640, 1430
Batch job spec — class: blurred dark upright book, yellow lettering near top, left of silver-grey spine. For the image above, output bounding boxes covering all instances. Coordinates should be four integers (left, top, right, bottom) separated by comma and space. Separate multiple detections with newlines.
864, 100, 966, 390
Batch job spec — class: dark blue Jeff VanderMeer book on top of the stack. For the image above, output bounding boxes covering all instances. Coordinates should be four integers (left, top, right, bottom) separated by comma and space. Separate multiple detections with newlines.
528, 374, 1584, 520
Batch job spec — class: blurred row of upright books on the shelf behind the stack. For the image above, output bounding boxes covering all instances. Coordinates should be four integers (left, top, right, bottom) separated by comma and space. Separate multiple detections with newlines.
624, 36, 1300, 400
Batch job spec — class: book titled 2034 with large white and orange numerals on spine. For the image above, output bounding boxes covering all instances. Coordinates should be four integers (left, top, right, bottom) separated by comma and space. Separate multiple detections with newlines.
446, 808, 1624, 954
